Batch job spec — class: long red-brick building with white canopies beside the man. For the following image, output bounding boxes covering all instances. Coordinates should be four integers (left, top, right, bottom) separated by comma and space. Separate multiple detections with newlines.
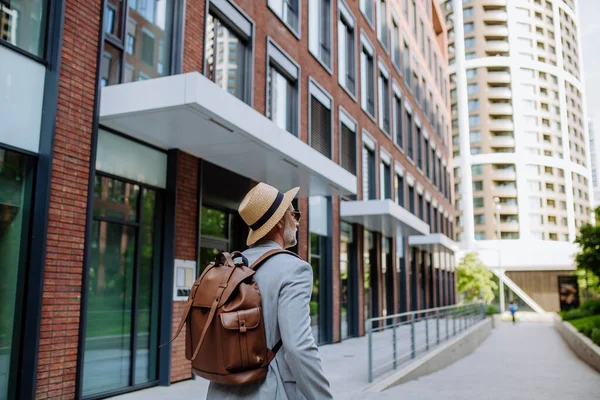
0, 0, 456, 399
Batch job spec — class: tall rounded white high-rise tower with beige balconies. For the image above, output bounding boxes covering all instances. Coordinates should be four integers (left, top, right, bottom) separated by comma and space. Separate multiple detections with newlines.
441, 0, 592, 311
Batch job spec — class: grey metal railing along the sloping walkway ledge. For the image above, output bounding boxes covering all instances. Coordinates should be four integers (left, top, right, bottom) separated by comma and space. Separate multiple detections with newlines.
365, 303, 485, 383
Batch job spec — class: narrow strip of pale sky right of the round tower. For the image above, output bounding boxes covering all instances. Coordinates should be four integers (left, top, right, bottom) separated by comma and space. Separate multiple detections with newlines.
579, 0, 600, 186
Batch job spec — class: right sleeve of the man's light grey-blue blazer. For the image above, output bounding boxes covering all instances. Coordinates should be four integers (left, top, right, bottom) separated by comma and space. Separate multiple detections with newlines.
278, 260, 333, 400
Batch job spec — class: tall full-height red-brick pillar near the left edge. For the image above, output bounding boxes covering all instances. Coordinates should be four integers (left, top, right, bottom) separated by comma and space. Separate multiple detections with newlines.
36, 0, 101, 399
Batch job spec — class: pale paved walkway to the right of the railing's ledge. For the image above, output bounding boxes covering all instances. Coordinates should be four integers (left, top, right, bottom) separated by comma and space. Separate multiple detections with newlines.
363, 322, 600, 400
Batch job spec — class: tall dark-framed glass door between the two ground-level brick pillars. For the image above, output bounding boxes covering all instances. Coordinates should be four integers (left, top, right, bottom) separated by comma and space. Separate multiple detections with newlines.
82, 175, 163, 397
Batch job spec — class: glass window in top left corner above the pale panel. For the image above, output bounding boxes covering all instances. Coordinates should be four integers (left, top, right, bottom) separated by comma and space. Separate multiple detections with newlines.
0, 0, 49, 57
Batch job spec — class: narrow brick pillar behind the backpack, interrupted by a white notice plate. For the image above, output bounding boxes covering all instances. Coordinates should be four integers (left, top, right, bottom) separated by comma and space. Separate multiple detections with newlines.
171, 152, 198, 382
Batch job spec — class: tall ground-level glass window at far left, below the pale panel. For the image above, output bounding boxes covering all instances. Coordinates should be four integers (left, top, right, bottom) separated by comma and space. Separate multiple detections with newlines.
0, 148, 34, 399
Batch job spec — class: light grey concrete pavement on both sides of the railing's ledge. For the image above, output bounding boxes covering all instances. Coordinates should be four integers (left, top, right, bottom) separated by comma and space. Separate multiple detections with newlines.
116, 322, 600, 400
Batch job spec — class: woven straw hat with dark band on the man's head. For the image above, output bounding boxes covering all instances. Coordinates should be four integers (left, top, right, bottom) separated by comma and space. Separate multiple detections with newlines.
238, 182, 300, 246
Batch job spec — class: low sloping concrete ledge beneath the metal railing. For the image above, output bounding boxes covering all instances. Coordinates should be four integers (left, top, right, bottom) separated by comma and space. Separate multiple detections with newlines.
365, 317, 493, 392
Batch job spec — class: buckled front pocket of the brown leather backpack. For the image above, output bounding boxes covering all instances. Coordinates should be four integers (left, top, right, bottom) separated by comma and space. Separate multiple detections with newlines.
220, 307, 267, 372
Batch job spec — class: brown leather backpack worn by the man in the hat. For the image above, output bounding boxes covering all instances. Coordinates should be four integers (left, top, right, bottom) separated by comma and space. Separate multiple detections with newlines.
171, 249, 298, 385
